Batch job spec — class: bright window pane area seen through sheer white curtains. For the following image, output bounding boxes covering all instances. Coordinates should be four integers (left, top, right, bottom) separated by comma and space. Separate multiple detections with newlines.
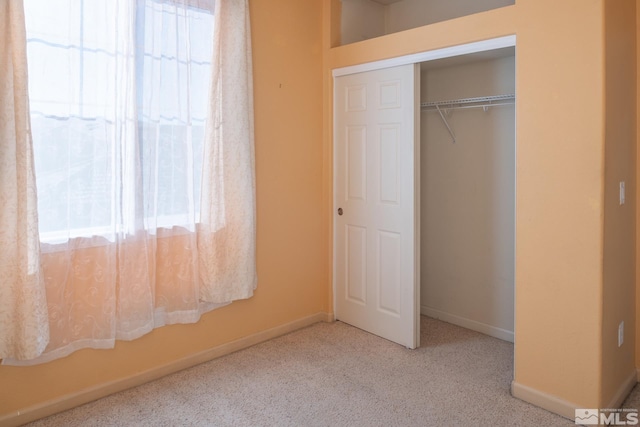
25, 0, 214, 242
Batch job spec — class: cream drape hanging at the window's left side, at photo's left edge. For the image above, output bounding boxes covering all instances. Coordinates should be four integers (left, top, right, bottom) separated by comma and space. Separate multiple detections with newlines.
0, 0, 49, 360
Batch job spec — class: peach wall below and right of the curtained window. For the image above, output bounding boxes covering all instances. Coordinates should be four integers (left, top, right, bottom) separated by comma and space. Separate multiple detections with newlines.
0, 0, 331, 424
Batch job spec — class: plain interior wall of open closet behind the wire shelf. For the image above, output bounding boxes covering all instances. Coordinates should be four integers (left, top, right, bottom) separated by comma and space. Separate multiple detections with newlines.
420, 55, 515, 341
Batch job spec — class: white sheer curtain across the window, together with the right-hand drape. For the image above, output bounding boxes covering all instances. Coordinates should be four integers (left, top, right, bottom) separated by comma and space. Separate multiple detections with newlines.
3, 0, 256, 364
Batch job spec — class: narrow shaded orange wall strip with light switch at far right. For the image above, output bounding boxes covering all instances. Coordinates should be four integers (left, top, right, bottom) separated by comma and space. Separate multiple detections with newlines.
601, 0, 637, 407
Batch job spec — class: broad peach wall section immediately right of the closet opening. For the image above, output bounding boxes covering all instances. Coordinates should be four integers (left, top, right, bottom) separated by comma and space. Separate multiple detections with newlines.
514, 0, 604, 416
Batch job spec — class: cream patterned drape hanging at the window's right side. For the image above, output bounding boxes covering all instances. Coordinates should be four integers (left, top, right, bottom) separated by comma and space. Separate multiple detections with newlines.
198, 0, 257, 302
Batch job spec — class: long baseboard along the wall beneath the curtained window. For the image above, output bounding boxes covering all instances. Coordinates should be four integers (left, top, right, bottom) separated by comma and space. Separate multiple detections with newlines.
0, 312, 333, 427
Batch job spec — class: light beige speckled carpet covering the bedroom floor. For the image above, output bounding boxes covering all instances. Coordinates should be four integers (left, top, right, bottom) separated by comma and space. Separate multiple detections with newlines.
23, 316, 596, 427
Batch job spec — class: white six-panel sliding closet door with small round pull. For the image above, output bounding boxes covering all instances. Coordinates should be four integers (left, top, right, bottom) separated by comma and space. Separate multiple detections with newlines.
334, 64, 419, 348
